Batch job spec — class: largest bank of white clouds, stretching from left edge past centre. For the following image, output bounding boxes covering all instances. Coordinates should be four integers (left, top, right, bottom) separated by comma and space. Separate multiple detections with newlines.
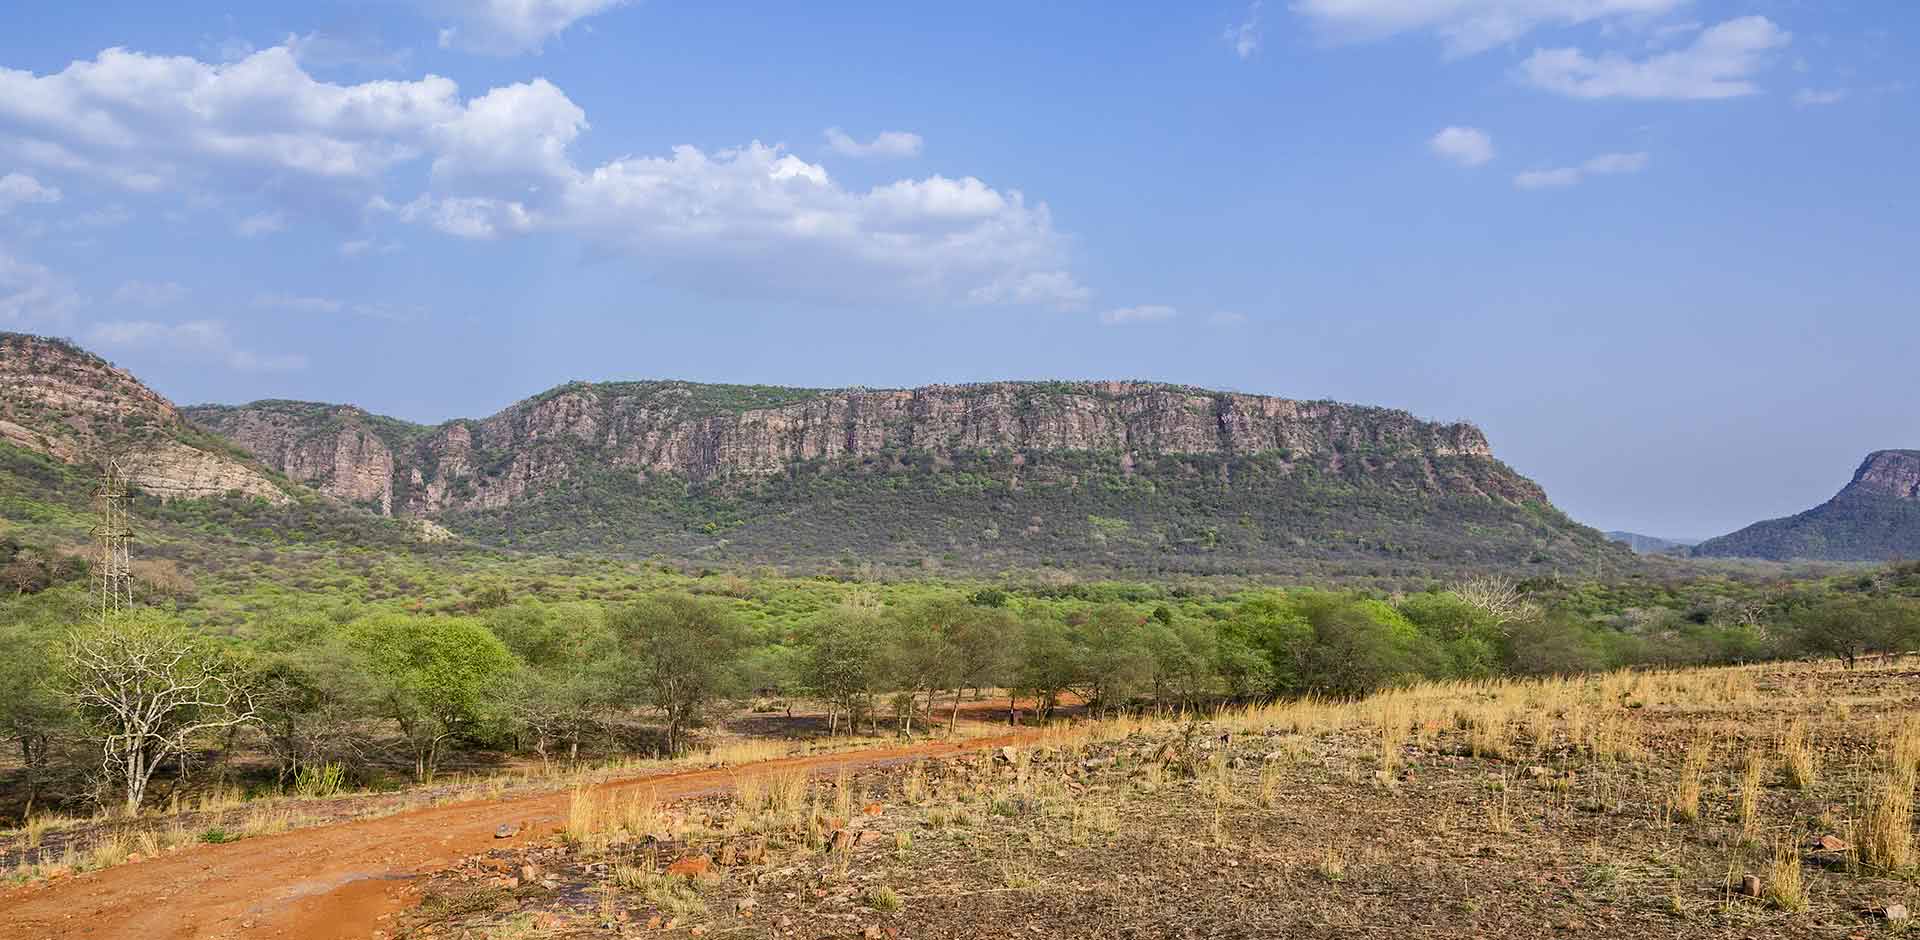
0, 46, 1089, 307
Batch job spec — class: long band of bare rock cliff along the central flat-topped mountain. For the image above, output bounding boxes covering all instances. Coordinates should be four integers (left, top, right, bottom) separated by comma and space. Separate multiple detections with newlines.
188, 382, 1546, 516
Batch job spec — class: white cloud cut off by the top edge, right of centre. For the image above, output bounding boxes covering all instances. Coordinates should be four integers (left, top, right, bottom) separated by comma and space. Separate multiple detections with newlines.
1292, 0, 1688, 56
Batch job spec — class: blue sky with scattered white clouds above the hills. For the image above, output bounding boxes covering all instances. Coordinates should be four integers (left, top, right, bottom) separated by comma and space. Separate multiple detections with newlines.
0, 0, 1920, 535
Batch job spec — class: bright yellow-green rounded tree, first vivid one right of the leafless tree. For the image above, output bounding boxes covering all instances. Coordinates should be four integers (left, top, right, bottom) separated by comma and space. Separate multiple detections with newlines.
346, 614, 518, 783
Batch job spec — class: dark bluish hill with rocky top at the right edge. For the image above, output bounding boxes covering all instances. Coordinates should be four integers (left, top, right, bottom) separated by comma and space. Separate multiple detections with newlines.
1693, 451, 1920, 562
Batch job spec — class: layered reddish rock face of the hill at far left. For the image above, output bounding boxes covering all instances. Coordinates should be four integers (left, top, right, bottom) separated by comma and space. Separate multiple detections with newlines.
0, 334, 290, 503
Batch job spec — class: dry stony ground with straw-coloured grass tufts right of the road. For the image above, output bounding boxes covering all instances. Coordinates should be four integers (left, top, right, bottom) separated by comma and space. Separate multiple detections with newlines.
388, 668, 1920, 938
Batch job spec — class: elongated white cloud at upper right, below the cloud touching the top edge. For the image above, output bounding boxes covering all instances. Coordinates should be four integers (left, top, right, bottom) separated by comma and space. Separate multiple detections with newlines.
1521, 15, 1793, 100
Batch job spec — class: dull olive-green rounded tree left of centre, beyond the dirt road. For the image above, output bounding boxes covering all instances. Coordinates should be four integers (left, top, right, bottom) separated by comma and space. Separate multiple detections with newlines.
611, 593, 747, 754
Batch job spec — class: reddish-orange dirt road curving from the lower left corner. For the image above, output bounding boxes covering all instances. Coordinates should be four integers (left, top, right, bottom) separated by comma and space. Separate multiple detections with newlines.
0, 733, 1031, 940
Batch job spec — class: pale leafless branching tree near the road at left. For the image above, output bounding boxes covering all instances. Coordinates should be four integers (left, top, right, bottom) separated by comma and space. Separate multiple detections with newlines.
61, 612, 255, 815
